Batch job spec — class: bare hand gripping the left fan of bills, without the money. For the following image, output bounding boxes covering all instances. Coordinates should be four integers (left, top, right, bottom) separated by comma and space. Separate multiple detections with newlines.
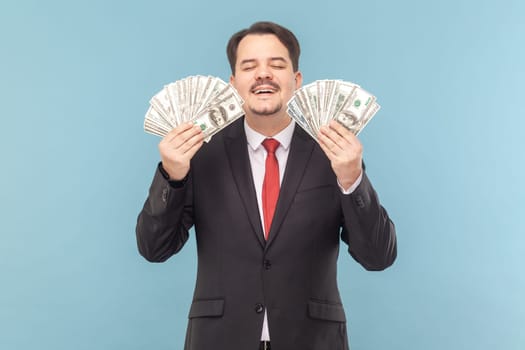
159, 122, 204, 181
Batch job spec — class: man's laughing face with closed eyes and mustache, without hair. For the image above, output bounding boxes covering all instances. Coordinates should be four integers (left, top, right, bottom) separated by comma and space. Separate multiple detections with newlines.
230, 34, 302, 118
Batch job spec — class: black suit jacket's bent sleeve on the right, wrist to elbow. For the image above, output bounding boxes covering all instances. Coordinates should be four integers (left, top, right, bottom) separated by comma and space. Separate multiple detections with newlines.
341, 171, 397, 271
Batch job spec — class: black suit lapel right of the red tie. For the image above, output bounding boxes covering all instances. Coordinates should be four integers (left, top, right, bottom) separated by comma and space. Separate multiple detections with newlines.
266, 125, 315, 249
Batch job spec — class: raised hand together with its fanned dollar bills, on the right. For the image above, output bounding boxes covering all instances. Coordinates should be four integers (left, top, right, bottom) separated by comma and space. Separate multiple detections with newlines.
288, 80, 380, 189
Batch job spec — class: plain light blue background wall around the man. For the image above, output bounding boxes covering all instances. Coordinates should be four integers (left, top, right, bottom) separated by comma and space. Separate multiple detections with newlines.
0, 0, 525, 350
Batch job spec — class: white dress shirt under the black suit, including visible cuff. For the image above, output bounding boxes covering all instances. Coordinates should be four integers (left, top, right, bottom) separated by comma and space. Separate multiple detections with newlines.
244, 119, 363, 341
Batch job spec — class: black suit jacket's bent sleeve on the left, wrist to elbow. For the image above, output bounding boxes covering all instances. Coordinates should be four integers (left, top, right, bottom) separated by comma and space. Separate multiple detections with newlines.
136, 168, 193, 262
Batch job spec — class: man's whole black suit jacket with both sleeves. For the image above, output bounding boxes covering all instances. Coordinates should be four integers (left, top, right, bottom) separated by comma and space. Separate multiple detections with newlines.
136, 119, 396, 350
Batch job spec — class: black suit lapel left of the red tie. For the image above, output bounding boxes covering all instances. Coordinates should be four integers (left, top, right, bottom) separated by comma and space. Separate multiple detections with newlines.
224, 118, 266, 247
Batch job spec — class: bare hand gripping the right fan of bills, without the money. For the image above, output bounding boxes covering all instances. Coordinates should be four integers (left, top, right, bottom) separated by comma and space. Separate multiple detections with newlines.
317, 120, 363, 189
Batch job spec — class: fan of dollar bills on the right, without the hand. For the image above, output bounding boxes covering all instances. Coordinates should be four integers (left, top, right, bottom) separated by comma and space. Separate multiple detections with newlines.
288, 80, 381, 139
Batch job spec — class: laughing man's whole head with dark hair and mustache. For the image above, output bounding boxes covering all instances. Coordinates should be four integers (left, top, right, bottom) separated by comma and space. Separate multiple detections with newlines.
227, 22, 302, 123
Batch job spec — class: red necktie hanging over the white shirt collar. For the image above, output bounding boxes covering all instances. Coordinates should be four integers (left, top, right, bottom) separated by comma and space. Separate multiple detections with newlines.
262, 139, 279, 239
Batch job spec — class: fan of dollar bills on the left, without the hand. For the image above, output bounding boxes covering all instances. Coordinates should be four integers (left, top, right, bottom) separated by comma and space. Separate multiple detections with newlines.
144, 75, 244, 141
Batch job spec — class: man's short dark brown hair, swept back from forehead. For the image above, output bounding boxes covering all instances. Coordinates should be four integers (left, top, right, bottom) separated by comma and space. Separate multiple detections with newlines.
226, 22, 301, 75
